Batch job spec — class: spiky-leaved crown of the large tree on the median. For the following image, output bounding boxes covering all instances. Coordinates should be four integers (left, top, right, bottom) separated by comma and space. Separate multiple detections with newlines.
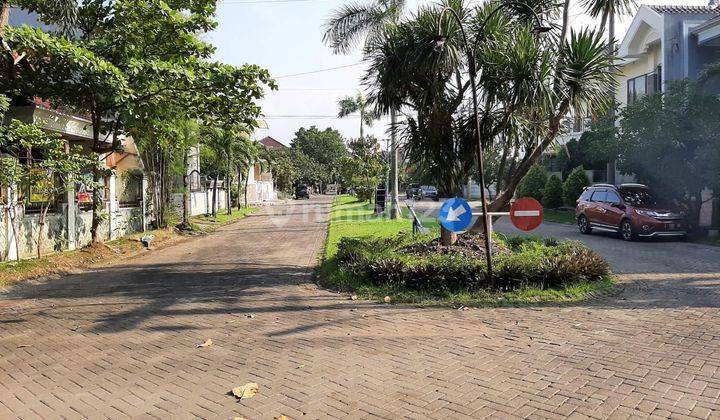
365, 1, 615, 223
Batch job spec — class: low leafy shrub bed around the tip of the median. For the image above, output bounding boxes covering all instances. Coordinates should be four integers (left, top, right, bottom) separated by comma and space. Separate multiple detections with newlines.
336, 234, 610, 294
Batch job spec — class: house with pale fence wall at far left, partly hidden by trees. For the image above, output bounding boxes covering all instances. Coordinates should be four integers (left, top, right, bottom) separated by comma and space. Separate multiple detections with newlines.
0, 9, 147, 261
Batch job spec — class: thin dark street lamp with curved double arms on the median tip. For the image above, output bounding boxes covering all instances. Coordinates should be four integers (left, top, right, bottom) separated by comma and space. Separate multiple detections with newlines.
436, 2, 552, 286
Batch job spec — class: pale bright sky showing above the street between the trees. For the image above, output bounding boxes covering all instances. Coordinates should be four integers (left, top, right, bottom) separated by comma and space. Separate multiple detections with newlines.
207, 0, 707, 145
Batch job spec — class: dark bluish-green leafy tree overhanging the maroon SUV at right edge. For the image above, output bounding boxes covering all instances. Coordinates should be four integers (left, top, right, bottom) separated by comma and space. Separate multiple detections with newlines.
617, 80, 720, 226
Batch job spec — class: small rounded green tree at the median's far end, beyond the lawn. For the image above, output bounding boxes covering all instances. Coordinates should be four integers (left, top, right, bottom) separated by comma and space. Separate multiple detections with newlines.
340, 136, 387, 201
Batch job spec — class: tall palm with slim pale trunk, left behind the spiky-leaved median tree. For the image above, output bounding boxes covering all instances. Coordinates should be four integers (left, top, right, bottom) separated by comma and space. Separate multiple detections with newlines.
323, 0, 406, 219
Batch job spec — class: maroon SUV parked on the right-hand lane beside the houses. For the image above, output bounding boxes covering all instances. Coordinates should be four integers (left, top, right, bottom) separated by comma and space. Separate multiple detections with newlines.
575, 184, 687, 241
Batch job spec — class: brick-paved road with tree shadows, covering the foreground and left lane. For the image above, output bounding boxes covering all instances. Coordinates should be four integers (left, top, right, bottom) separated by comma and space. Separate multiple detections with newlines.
0, 200, 720, 419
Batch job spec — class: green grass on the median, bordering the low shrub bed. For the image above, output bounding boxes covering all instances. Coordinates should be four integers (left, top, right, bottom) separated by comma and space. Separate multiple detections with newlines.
319, 196, 614, 306
